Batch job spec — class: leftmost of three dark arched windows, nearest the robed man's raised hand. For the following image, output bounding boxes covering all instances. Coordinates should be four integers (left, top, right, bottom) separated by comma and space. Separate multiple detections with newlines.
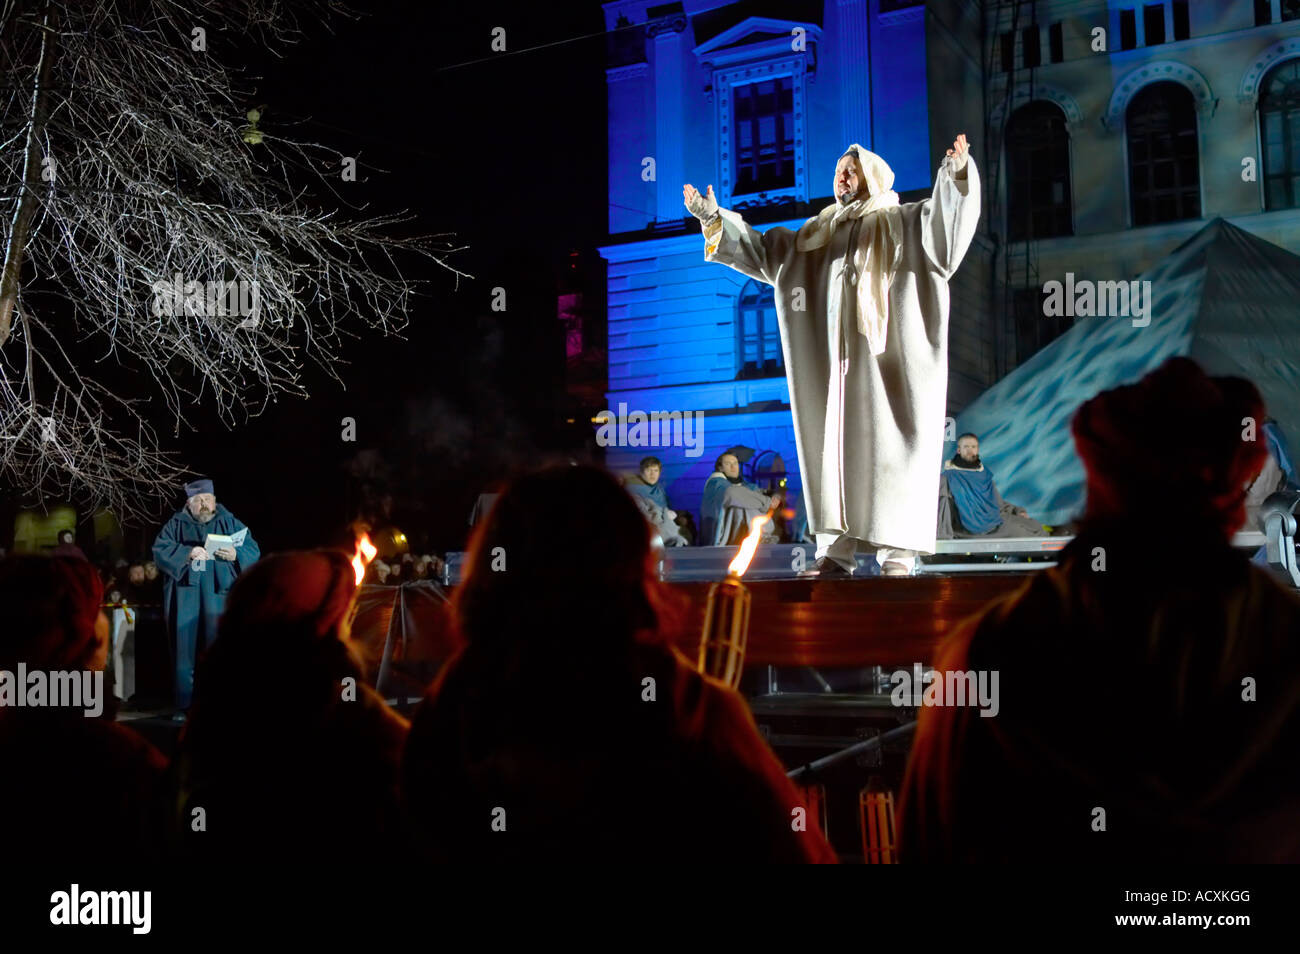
1006, 100, 1074, 242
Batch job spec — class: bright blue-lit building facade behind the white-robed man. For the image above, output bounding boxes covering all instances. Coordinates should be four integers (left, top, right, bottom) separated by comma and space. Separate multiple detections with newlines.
599, 0, 988, 527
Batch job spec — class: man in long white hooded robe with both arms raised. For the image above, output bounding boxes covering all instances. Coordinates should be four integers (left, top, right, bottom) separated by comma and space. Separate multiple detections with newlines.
683, 135, 980, 576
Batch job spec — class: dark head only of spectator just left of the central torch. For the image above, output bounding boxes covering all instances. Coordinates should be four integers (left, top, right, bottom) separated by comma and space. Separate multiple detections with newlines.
452, 465, 676, 654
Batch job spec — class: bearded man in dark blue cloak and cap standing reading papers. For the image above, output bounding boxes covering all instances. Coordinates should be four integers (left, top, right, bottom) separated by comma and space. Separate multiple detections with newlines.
153, 478, 261, 708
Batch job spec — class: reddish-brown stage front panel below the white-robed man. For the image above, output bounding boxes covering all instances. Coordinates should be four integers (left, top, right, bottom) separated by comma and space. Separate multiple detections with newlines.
668, 571, 1039, 668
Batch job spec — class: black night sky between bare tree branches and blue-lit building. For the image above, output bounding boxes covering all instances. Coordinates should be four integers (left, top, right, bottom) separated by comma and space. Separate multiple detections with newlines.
170, 3, 606, 548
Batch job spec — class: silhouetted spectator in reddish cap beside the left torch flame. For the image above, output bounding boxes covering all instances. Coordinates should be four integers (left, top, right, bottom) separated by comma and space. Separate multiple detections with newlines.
173, 550, 406, 862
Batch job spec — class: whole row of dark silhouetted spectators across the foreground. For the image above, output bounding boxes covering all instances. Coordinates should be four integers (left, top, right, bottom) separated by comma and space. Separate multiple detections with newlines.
0, 359, 1300, 863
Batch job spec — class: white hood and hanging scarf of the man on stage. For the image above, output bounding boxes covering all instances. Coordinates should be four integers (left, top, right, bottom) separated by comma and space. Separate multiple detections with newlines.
796, 143, 902, 355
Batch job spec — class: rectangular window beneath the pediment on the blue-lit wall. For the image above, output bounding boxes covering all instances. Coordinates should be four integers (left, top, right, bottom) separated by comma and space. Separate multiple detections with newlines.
733, 77, 794, 195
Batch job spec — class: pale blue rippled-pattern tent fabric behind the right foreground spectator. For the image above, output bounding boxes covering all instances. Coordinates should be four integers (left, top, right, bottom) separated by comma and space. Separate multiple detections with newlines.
945, 218, 1300, 525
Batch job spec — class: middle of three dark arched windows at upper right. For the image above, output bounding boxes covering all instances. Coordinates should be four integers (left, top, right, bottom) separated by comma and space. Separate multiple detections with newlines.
1126, 82, 1201, 226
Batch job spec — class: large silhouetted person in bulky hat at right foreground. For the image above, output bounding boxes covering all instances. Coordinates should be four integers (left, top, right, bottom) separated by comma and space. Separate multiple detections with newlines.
898, 357, 1300, 863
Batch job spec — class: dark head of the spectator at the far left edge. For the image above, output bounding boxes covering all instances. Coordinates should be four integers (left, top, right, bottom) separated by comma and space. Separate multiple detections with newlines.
0, 556, 108, 672
